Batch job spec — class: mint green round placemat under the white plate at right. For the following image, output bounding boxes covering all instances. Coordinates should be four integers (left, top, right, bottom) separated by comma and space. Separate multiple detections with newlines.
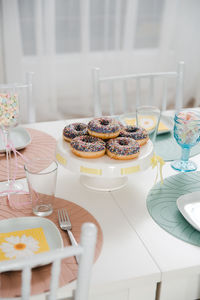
146, 172, 200, 246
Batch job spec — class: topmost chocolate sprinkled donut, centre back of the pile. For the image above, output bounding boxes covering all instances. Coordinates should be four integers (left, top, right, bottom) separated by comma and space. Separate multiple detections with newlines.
88, 117, 121, 139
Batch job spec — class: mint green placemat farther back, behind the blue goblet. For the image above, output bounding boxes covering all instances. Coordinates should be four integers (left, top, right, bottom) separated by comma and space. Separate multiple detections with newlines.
155, 133, 200, 161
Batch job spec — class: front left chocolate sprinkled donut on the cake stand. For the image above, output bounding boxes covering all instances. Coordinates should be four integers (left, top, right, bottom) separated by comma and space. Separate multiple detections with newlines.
70, 135, 106, 158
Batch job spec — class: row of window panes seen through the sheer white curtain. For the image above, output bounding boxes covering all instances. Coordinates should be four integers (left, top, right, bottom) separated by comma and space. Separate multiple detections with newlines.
18, 0, 165, 56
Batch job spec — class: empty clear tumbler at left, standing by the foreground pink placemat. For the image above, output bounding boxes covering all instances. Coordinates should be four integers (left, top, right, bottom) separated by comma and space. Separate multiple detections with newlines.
24, 159, 58, 217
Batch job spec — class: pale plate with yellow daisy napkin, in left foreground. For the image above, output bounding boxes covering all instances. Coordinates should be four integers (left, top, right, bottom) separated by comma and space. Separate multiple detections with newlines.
0, 217, 63, 261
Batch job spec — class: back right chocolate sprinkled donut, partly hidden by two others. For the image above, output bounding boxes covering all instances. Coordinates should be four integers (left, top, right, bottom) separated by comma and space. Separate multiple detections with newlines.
119, 125, 149, 146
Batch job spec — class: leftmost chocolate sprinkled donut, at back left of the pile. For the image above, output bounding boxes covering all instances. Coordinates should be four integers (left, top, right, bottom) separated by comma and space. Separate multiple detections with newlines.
63, 123, 88, 142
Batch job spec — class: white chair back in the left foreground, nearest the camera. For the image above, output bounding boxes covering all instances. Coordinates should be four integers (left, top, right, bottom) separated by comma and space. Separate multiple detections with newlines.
0, 223, 97, 300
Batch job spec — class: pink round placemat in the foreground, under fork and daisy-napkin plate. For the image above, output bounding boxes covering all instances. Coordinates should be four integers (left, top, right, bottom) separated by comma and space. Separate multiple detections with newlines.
0, 195, 103, 297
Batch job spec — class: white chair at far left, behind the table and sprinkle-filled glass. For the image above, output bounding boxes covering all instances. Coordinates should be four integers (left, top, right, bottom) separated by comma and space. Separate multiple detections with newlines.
0, 72, 36, 123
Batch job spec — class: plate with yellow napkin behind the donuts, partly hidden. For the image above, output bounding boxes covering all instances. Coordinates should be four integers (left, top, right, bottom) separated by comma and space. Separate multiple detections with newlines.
119, 113, 173, 135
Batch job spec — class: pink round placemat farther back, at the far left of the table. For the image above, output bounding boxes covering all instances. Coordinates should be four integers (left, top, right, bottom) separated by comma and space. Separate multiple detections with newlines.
0, 128, 56, 181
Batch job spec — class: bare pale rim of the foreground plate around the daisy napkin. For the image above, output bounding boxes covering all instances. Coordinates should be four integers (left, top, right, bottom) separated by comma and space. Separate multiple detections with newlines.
0, 217, 63, 264
